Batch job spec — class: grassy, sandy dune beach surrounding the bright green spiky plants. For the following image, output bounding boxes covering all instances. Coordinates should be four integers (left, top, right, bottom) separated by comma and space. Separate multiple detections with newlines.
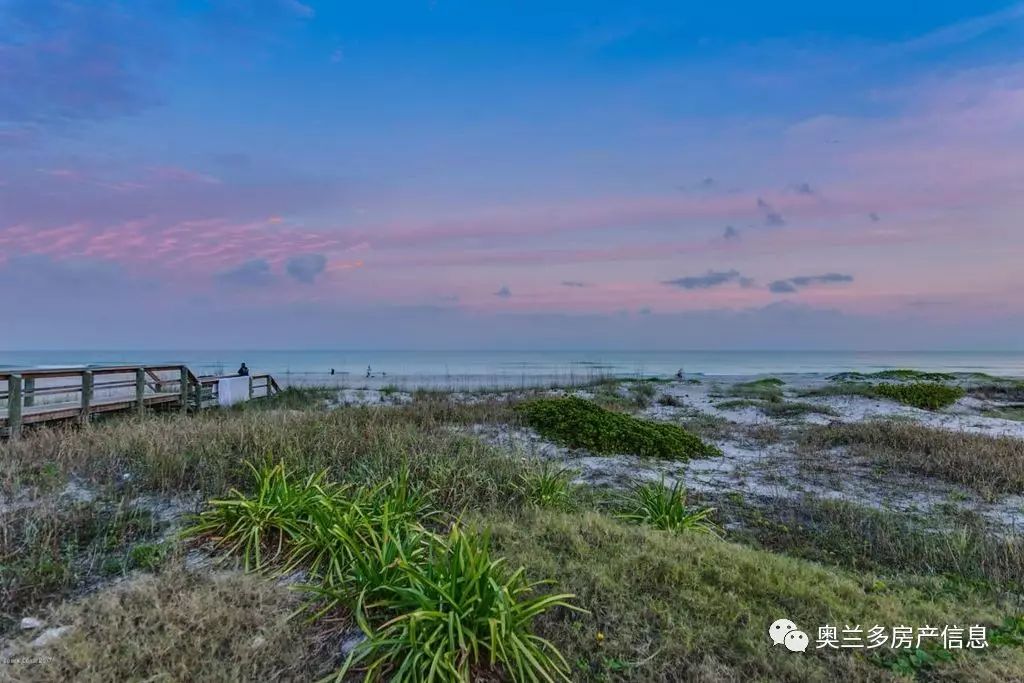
0, 369, 1024, 681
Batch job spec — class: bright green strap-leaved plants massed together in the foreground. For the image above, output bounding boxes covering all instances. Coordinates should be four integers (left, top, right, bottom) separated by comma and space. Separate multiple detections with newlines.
189, 464, 573, 683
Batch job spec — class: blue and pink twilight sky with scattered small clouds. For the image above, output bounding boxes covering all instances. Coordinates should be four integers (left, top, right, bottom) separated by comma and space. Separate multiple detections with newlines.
0, 0, 1024, 350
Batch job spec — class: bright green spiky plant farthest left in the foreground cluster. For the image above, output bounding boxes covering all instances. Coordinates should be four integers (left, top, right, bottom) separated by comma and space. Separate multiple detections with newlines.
184, 463, 345, 570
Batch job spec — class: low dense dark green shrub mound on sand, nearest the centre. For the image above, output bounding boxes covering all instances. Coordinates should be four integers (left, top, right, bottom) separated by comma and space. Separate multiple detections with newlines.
518, 396, 720, 460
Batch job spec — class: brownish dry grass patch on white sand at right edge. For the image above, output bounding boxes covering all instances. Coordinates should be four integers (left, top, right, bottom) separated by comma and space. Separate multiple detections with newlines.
804, 420, 1024, 496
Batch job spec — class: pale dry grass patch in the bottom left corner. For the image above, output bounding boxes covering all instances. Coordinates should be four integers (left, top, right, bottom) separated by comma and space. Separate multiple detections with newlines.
16, 567, 332, 683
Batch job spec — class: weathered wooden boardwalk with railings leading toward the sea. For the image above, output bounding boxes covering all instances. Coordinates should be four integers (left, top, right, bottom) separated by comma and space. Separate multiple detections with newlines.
0, 366, 281, 438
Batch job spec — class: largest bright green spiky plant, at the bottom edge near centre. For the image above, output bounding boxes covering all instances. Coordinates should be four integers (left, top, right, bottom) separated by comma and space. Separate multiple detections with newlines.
338, 525, 577, 683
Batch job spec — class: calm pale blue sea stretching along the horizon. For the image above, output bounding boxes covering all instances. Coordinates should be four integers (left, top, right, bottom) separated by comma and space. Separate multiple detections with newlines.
0, 349, 1024, 386
